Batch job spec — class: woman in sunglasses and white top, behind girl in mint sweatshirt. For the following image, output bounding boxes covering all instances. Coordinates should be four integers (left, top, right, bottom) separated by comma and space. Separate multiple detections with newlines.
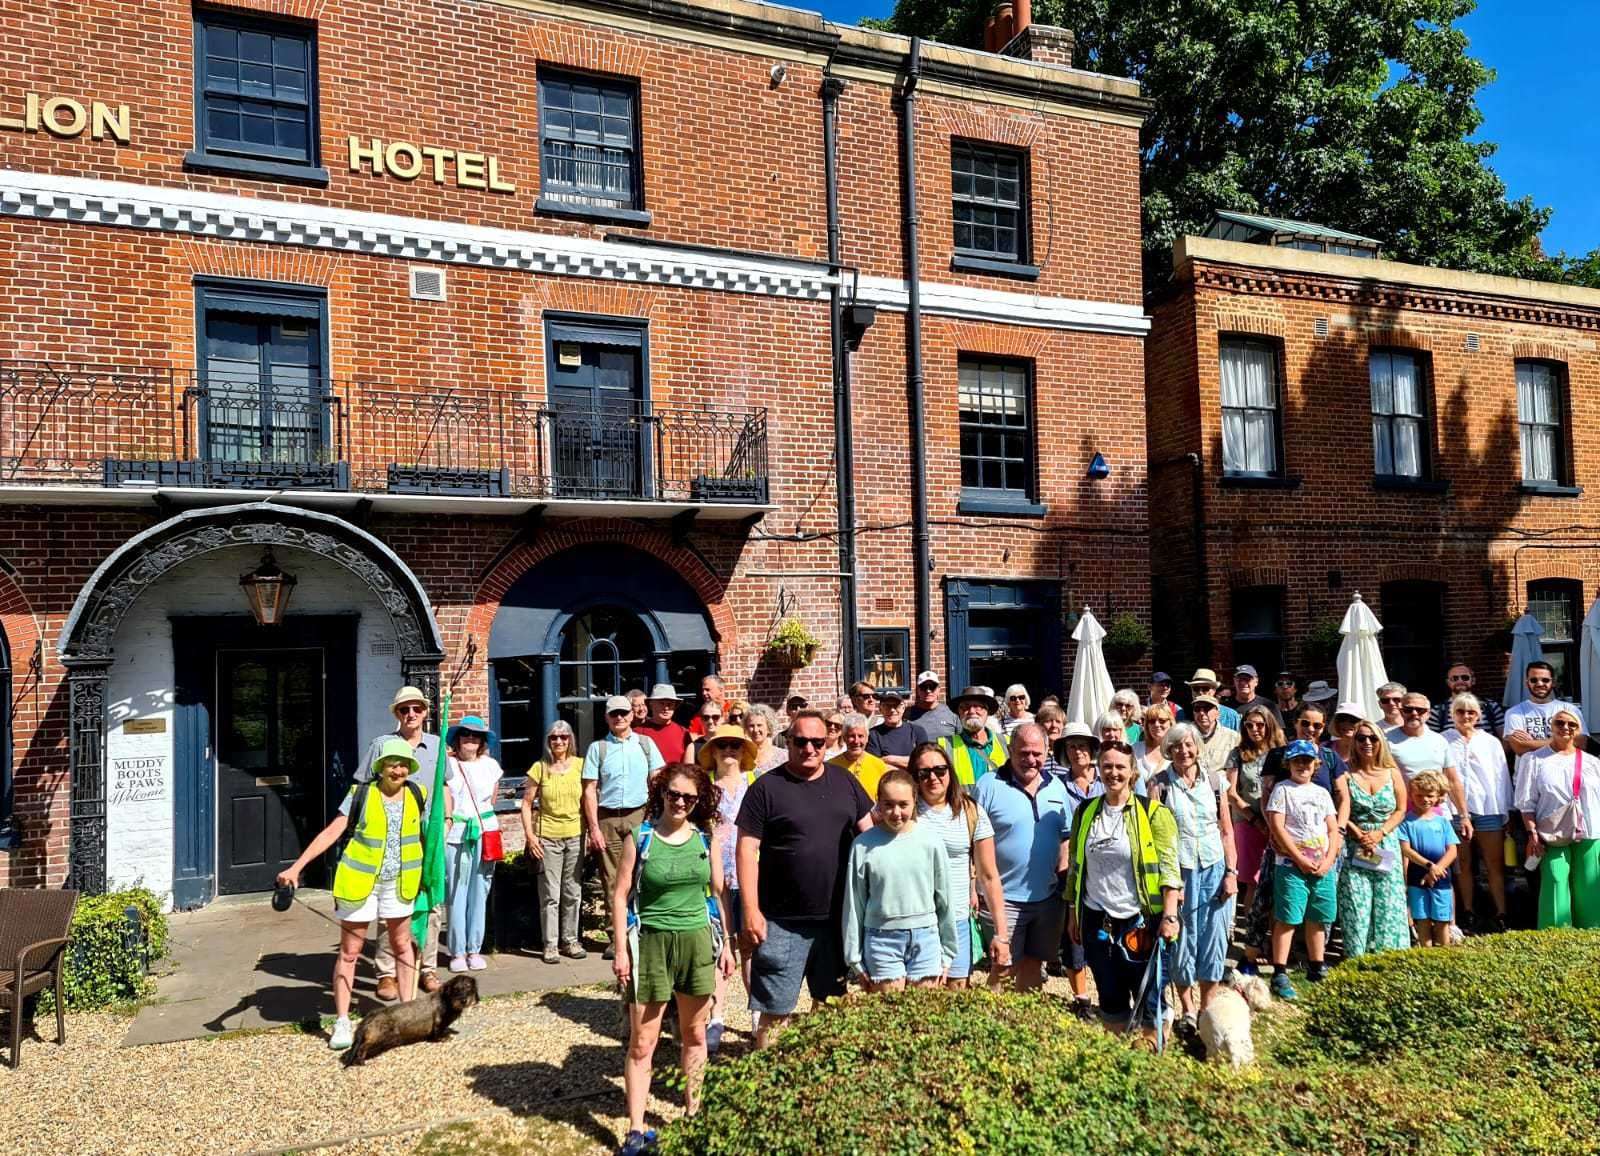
910, 743, 1011, 988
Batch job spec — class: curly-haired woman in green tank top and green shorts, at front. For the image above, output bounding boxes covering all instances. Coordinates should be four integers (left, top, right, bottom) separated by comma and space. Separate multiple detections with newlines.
611, 762, 733, 1153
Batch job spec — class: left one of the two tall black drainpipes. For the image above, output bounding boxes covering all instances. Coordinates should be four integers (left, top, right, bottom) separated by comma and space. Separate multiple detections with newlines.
822, 77, 861, 687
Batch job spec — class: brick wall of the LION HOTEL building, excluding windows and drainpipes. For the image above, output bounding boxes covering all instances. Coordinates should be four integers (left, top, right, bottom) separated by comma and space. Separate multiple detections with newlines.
0, 0, 1149, 885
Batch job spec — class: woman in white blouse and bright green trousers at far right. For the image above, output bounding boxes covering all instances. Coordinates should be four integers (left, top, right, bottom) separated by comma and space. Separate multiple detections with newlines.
1515, 704, 1600, 930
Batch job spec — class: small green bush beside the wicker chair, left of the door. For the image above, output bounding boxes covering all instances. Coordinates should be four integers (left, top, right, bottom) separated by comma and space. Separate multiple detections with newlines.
40, 887, 168, 1014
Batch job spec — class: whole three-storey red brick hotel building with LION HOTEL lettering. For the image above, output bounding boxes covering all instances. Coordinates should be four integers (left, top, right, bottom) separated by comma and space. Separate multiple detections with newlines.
0, 0, 1149, 905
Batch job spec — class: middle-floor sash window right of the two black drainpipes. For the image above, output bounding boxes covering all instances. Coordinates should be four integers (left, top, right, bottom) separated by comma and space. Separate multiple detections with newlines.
957, 357, 1034, 504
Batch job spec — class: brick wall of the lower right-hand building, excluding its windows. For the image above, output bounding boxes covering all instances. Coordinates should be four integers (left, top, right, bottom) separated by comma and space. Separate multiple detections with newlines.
1146, 237, 1600, 696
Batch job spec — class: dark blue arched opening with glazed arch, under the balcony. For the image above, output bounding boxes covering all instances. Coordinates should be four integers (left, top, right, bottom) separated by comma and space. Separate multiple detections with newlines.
488, 543, 715, 775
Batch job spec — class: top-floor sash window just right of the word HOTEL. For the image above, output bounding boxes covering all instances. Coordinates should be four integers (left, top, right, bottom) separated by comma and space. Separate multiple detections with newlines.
539, 69, 643, 215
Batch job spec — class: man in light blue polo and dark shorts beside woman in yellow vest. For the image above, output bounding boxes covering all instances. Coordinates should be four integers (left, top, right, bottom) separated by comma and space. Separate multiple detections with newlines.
973, 722, 1074, 991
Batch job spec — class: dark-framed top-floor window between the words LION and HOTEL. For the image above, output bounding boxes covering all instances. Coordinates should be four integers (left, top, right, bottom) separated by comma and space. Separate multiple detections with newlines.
184, 8, 328, 184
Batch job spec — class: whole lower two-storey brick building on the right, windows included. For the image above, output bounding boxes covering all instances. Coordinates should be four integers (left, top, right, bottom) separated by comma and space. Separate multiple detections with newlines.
1146, 223, 1600, 701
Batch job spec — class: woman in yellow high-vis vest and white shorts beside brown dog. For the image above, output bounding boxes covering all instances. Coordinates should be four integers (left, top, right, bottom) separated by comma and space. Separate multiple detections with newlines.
278, 738, 422, 1050
